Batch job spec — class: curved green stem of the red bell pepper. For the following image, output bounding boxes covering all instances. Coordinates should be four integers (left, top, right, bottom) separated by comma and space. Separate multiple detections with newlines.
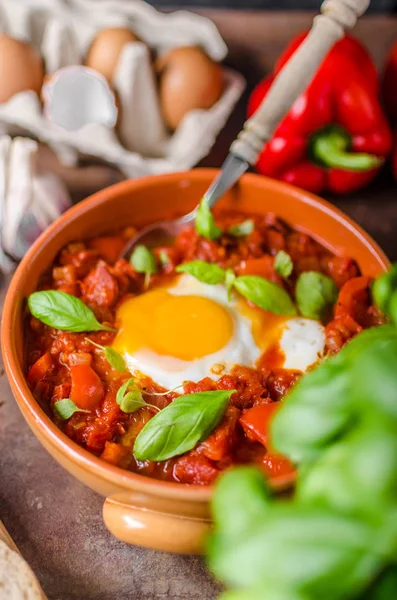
310, 125, 383, 172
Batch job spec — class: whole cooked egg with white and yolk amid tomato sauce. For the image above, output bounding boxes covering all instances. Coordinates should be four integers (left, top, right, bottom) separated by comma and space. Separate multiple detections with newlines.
113, 274, 325, 389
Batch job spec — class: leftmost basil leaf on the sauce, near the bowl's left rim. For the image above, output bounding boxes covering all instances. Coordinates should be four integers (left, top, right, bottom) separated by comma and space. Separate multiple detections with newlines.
28, 290, 114, 333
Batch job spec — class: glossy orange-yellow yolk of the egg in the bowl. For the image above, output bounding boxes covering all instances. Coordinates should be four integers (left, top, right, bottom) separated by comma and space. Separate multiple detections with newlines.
113, 289, 234, 361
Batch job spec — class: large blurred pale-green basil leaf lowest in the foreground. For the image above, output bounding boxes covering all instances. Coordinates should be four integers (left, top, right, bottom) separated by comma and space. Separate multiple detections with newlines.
209, 500, 378, 600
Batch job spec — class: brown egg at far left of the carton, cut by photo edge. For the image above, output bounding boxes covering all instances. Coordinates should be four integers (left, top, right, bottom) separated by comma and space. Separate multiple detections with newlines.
0, 34, 44, 103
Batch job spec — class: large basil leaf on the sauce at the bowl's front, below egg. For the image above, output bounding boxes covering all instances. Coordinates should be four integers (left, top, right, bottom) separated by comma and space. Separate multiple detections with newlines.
134, 390, 236, 461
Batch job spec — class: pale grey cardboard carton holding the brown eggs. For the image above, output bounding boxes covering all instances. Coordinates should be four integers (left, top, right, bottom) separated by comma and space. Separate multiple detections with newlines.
0, 0, 245, 178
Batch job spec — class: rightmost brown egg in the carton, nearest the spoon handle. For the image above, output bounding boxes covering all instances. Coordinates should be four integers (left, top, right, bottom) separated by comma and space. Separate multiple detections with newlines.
156, 46, 224, 130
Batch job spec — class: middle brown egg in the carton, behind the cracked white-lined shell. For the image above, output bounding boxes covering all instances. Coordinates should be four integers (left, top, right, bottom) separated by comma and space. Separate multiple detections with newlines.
85, 27, 141, 82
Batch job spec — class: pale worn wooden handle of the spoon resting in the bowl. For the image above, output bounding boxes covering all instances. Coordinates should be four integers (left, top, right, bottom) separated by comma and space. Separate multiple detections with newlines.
230, 0, 370, 165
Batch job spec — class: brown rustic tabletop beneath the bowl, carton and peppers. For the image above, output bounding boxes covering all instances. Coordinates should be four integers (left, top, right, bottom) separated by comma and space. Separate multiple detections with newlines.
0, 11, 397, 600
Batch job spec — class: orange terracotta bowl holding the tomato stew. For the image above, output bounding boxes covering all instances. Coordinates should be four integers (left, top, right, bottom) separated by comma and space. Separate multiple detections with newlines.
1, 169, 389, 553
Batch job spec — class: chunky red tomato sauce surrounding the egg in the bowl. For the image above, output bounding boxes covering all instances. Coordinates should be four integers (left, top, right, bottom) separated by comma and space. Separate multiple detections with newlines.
26, 212, 383, 485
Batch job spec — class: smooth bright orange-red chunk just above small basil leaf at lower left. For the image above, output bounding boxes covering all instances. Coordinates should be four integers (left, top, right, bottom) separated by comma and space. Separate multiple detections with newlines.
70, 365, 104, 410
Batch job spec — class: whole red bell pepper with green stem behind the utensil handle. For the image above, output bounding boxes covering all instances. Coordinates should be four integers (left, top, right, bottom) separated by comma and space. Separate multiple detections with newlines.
248, 32, 391, 193
